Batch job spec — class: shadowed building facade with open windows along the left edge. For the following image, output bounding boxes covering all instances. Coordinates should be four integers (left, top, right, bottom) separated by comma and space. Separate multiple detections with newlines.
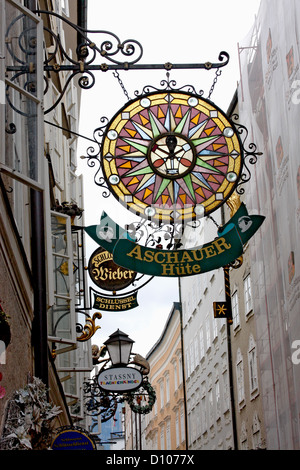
0, 0, 93, 449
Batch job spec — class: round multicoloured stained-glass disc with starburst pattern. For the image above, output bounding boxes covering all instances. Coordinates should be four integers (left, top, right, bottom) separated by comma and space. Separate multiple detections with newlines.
101, 91, 242, 222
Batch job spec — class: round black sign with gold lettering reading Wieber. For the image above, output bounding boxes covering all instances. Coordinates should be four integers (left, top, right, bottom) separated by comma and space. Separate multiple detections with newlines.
88, 247, 136, 292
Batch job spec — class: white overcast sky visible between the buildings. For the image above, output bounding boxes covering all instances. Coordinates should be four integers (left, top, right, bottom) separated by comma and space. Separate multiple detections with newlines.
78, 0, 260, 356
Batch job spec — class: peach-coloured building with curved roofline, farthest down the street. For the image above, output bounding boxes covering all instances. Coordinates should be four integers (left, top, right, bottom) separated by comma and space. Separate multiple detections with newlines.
142, 303, 186, 450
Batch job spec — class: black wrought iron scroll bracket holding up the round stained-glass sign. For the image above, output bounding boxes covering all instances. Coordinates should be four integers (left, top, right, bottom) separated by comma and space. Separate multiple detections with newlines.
6, 10, 229, 114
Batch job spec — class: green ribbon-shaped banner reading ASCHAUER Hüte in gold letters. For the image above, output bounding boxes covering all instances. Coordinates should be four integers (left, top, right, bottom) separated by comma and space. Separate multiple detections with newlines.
85, 204, 265, 277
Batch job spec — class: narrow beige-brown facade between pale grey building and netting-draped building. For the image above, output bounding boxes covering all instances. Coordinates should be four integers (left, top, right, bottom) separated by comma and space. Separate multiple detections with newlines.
222, 93, 266, 450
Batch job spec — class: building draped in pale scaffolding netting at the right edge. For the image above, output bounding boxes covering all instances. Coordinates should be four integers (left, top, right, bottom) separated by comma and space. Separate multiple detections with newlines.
238, 0, 300, 450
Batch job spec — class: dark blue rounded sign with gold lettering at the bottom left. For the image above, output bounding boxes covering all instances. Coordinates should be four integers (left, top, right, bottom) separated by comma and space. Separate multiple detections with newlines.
51, 427, 97, 450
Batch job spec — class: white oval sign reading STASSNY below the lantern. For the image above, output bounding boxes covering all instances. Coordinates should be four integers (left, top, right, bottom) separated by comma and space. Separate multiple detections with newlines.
97, 367, 143, 392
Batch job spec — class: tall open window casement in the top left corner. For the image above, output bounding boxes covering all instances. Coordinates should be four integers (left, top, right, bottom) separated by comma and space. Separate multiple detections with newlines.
0, 2, 45, 189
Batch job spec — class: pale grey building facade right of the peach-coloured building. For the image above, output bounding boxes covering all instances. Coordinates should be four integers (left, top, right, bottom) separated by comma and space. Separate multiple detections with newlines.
180, 213, 235, 450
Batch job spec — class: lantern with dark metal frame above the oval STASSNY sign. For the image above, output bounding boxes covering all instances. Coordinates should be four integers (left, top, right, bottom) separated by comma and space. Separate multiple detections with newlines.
104, 329, 134, 367
